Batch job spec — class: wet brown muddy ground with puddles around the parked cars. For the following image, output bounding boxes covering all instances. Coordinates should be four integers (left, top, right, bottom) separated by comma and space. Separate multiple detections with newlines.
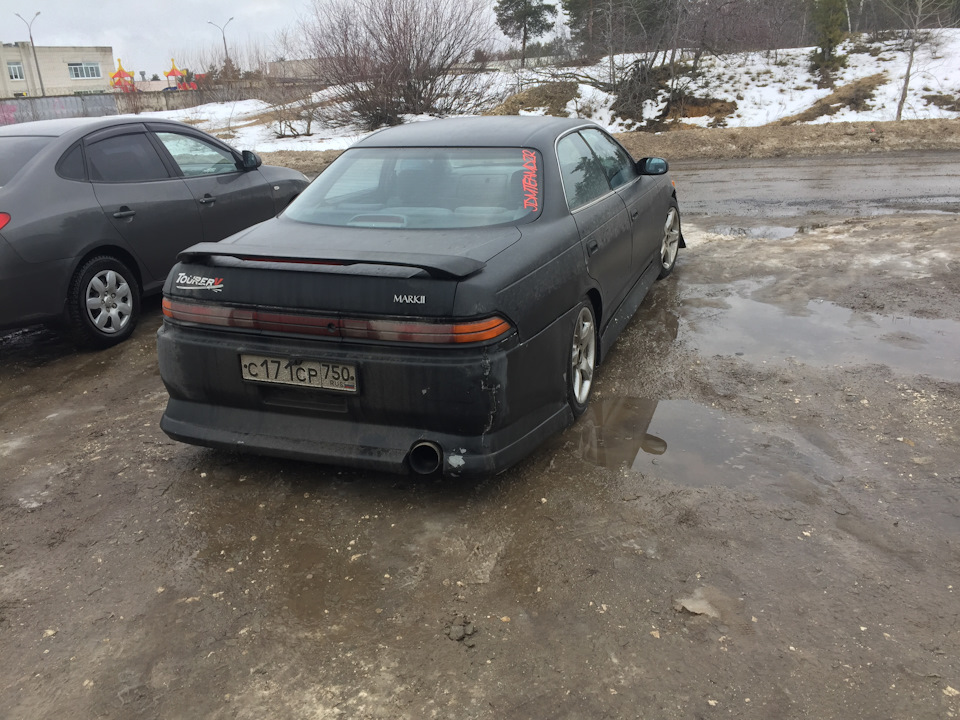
0, 123, 960, 720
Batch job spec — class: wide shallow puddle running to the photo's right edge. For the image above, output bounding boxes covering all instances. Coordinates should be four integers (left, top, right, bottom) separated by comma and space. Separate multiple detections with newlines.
683, 295, 960, 382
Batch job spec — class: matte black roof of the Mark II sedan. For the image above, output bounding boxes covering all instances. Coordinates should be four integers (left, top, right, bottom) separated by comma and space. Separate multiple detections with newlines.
354, 115, 596, 148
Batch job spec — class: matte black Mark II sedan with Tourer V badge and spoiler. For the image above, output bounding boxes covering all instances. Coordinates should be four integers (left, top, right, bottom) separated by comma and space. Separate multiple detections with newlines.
158, 117, 684, 476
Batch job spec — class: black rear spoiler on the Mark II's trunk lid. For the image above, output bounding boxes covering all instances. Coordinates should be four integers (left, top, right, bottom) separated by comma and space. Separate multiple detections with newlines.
177, 243, 486, 280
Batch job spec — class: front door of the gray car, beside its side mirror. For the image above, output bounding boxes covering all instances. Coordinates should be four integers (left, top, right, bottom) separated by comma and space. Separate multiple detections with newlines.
156, 129, 276, 242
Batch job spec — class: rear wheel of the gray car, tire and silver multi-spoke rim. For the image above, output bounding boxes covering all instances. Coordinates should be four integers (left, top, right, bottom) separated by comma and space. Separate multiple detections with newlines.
67, 255, 140, 348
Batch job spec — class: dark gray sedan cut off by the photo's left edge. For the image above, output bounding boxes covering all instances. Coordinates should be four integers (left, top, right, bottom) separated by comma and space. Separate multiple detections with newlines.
0, 117, 307, 347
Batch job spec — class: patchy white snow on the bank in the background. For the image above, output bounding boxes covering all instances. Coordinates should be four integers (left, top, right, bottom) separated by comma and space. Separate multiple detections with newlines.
141, 29, 960, 152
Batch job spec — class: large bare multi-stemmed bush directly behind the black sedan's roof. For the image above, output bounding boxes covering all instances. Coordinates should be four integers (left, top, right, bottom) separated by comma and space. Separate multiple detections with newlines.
302, 0, 494, 129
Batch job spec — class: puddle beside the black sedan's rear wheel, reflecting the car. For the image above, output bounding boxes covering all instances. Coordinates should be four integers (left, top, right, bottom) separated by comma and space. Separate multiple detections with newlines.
577, 398, 843, 504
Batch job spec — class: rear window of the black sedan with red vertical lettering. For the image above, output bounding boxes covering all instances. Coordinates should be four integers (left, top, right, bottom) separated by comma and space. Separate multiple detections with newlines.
284, 148, 543, 229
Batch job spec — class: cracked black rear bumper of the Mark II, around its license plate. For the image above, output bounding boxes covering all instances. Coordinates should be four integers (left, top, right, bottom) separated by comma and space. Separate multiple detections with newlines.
157, 318, 573, 477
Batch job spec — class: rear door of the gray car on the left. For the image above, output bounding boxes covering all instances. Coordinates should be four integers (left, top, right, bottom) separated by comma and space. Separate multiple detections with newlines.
85, 126, 203, 290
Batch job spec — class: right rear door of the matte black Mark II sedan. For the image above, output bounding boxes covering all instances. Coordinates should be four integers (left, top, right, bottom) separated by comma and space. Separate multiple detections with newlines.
557, 133, 633, 317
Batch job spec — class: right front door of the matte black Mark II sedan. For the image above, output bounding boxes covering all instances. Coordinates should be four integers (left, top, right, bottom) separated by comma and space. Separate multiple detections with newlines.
580, 129, 666, 276
